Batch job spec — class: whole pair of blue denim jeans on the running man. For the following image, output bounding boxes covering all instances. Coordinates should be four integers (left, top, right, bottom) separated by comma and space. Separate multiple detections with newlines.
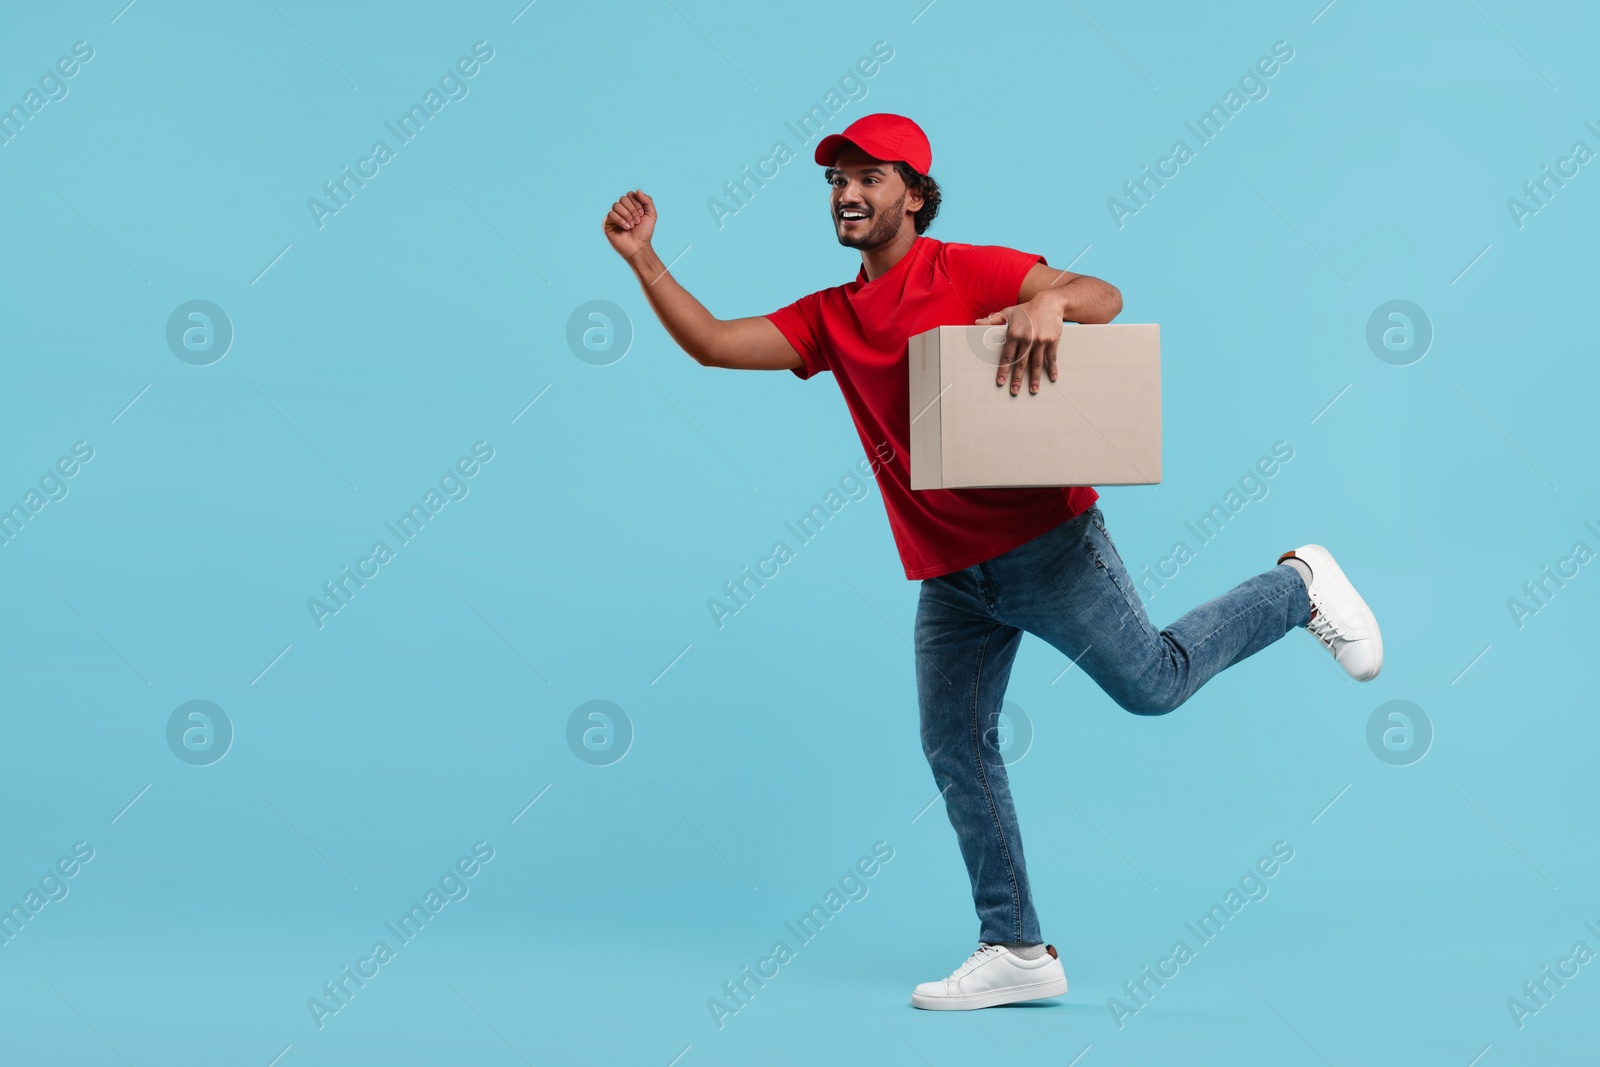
915, 506, 1310, 942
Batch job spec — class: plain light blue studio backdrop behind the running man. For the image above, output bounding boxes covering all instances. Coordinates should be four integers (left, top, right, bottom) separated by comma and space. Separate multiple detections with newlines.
0, 0, 1600, 1067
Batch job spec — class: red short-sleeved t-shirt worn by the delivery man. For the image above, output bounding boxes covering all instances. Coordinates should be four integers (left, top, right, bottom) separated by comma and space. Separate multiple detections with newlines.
766, 237, 1099, 579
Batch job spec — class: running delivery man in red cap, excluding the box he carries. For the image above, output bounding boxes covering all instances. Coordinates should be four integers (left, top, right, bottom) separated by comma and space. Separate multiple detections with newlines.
605, 114, 1382, 1009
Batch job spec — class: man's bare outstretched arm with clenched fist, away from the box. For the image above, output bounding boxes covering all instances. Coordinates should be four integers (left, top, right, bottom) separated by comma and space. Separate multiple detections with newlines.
605, 189, 805, 371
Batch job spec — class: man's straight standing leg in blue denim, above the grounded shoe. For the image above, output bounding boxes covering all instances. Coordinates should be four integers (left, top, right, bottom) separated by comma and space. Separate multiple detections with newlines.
915, 568, 1040, 944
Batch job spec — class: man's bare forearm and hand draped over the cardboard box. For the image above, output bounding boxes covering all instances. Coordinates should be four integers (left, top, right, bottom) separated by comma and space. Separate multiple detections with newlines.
978, 262, 1122, 397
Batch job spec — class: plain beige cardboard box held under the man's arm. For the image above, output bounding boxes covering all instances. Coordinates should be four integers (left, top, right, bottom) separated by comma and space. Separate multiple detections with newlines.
910, 323, 1162, 490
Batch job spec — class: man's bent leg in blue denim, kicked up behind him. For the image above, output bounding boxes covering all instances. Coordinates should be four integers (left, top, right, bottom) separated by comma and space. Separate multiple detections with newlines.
979, 506, 1312, 715
